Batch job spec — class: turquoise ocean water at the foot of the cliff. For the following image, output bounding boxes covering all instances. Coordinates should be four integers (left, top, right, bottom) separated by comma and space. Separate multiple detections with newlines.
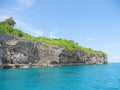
0, 63, 120, 90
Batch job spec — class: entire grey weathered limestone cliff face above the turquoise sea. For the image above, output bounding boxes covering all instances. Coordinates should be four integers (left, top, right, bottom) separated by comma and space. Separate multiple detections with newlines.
0, 33, 107, 69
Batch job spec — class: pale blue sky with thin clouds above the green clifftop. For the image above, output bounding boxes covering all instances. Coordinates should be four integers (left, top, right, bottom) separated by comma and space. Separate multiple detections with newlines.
0, 0, 120, 62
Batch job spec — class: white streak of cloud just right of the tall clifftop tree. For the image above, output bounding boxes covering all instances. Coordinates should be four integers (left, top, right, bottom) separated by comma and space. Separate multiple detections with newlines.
15, 20, 43, 36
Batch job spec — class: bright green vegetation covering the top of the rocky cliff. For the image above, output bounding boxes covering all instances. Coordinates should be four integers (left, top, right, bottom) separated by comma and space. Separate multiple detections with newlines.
0, 17, 106, 56
